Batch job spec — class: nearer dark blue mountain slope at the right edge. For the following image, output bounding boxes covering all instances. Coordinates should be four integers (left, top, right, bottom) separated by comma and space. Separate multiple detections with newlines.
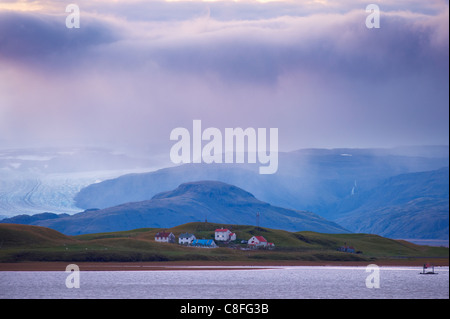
336, 167, 449, 240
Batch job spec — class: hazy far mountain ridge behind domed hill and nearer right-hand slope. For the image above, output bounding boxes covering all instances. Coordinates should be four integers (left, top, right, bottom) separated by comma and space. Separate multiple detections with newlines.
75, 146, 448, 219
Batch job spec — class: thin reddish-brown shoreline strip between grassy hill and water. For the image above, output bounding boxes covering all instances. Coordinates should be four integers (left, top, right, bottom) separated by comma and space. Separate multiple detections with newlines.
0, 258, 449, 271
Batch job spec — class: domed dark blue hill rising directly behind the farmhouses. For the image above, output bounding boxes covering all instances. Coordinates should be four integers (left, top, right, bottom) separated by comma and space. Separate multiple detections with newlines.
10, 181, 348, 235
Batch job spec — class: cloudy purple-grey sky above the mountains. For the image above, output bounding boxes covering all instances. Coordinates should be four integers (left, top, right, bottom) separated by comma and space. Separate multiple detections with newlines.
0, 0, 449, 155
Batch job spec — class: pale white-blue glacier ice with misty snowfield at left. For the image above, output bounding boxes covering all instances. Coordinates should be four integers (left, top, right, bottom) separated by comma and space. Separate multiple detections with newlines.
0, 147, 161, 217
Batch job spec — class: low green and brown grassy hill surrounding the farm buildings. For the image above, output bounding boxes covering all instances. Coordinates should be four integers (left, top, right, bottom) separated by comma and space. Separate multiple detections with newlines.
0, 222, 449, 262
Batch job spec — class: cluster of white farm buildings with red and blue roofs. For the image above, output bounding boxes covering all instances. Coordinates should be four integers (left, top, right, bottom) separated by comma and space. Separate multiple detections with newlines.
155, 228, 275, 249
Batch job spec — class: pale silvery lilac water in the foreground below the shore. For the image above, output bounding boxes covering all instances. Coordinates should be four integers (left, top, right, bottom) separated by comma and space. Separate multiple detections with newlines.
0, 267, 449, 299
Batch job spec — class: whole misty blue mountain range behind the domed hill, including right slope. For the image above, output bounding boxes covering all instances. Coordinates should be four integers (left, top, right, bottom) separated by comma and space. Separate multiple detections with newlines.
75, 146, 448, 239
